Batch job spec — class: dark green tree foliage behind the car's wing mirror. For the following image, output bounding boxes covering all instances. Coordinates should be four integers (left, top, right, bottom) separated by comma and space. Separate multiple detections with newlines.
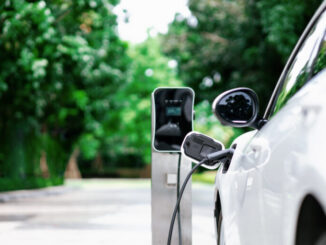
164, 0, 321, 111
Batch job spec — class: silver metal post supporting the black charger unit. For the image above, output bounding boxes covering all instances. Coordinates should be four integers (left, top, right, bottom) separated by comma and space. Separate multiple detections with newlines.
151, 151, 192, 245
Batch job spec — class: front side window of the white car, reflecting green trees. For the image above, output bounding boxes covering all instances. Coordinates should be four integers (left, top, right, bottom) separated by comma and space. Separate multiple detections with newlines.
273, 12, 326, 114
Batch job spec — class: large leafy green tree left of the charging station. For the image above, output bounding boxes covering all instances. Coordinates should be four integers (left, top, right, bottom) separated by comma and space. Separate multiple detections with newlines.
0, 0, 129, 188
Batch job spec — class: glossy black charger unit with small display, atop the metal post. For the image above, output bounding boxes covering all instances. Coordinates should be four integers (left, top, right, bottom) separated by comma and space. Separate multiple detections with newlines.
154, 88, 194, 151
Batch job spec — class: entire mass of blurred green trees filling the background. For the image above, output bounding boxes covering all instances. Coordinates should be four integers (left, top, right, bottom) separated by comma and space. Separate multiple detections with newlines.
0, 0, 321, 190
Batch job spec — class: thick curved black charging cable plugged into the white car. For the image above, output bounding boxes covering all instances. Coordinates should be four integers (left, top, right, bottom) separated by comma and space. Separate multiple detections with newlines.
167, 149, 234, 245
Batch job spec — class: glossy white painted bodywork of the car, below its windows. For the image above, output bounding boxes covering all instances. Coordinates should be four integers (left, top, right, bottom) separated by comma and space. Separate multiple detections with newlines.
216, 70, 326, 245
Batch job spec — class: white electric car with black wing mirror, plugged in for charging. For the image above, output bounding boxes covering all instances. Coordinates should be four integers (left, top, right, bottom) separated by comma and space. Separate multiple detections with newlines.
213, 1, 326, 245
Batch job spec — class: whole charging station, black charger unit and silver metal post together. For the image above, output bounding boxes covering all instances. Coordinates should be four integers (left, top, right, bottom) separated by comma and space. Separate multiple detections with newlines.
151, 88, 195, 245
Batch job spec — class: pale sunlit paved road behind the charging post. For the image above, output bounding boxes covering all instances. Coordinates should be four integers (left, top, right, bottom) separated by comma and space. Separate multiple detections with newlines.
0, 180, 215, 245
